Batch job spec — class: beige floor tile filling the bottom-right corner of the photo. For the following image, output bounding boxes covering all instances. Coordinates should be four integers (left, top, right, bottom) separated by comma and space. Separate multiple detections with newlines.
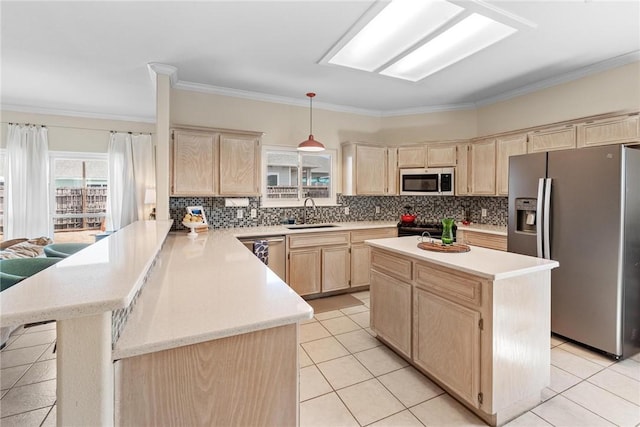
562, 381, 640, 426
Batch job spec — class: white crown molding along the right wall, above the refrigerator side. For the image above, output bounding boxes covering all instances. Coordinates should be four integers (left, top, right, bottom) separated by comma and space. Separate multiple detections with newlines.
475, 50, 640, 107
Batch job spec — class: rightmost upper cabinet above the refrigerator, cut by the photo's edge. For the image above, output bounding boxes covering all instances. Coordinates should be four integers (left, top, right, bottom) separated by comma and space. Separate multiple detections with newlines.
577, 113, 640, 148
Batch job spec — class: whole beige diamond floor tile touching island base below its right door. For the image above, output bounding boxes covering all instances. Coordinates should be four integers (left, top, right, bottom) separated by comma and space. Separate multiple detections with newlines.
378, 366, 444, 407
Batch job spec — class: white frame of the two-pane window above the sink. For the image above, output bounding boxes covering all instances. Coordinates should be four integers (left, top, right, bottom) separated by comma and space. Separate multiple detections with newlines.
260, 145, 339, 208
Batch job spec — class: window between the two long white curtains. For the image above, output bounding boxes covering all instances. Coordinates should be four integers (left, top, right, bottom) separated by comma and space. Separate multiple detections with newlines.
49, 152, 108, 233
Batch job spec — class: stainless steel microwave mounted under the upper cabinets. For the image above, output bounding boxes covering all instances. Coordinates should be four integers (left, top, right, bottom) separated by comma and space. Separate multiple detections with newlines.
400, 168, 455, 196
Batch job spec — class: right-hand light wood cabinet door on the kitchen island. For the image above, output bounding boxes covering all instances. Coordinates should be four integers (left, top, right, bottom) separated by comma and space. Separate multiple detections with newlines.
416, 288, 480, 407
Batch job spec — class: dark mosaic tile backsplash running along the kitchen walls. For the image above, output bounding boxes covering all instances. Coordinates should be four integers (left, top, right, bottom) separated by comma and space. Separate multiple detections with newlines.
169, 195, 508, 230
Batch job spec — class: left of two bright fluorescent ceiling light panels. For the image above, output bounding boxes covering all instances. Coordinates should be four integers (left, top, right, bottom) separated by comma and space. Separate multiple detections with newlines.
329, 0, 464, 71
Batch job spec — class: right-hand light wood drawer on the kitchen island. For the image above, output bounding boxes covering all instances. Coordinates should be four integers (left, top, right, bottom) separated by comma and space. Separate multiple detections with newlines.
414, 262, 482, 306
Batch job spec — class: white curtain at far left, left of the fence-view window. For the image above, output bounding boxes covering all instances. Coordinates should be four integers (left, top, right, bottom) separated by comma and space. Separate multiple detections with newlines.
4, 124, 53, 240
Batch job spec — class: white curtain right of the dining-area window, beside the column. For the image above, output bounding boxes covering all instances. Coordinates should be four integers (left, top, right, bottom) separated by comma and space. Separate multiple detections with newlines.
106, 132, 155, 231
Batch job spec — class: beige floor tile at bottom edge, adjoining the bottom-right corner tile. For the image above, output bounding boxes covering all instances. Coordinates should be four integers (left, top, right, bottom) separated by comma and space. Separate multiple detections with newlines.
531, 395, 614, 427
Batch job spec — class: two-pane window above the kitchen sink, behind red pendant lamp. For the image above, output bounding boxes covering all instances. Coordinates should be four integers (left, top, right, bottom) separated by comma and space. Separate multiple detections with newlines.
262, 147, 336, 206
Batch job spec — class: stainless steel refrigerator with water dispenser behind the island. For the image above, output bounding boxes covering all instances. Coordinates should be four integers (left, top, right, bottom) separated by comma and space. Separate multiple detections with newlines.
508, 145, 640, 358
